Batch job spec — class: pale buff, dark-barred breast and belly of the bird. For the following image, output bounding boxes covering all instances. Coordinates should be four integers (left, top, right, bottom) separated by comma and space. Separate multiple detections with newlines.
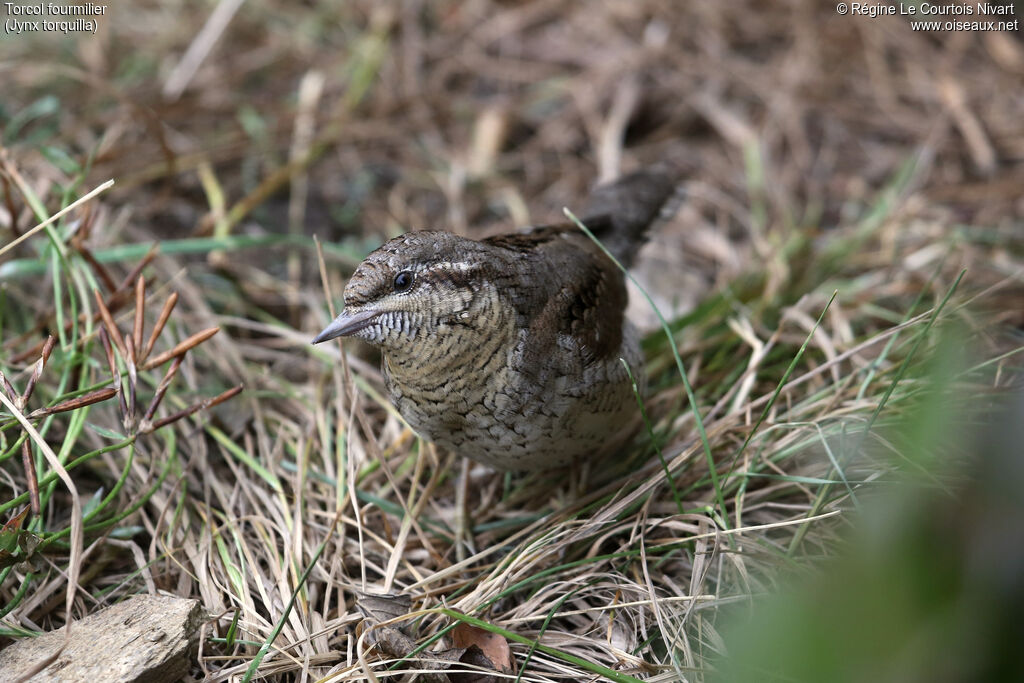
384, 317, 643, 469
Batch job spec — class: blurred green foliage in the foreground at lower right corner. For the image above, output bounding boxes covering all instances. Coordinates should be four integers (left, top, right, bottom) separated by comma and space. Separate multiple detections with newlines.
710, 335, 1024, 683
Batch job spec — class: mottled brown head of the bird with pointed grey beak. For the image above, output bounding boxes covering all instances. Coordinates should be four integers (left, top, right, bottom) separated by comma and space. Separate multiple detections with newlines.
313, 230, 495, 353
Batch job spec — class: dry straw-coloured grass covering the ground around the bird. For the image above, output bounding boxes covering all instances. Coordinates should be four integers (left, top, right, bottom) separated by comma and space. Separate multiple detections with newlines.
0, 0, 1024, 681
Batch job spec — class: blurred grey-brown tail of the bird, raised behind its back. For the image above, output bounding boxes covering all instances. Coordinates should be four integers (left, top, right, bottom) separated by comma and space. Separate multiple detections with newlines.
582, 162, 683, 267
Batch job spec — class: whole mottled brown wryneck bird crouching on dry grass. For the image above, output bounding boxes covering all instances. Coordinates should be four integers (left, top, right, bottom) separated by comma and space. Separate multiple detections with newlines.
312, 164, 678, 471
